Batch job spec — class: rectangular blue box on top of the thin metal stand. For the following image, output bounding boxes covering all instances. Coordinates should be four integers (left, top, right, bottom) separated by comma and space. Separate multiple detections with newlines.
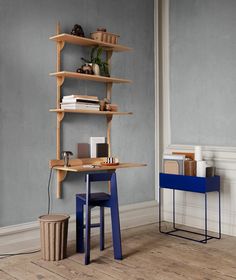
160, 173, 220, 193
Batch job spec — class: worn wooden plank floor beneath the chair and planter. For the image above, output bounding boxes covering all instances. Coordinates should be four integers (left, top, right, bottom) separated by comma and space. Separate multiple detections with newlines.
0, 225, 236, 280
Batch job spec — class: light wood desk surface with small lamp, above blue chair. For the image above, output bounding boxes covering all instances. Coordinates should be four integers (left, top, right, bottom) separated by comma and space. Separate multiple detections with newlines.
53, 163, 147, 172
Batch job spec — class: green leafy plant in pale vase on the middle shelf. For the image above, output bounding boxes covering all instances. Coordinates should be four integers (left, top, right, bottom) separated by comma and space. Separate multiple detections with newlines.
81, 46, 110, 77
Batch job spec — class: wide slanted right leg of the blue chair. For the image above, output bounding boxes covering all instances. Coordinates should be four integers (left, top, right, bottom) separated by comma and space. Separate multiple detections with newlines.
111, 173, 122, 260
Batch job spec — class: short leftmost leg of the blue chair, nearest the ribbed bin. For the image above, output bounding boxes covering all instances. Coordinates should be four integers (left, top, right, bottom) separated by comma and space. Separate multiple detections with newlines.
76, 199, 84, 253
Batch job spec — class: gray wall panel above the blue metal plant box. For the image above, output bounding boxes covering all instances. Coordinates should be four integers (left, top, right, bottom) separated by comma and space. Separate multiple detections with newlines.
170, 0, 236, 146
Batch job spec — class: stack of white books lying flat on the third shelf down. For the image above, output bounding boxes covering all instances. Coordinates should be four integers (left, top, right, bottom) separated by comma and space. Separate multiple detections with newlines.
61, 95, 100, 111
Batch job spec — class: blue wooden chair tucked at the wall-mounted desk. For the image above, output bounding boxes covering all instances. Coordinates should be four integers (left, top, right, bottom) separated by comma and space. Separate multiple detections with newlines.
76, 172, 122, 265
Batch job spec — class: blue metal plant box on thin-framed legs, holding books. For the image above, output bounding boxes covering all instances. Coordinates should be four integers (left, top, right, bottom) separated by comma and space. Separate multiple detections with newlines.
159, 173, 221, 243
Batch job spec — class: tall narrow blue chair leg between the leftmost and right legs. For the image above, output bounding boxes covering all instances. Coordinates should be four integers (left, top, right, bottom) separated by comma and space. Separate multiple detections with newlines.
84, 174, 91, 265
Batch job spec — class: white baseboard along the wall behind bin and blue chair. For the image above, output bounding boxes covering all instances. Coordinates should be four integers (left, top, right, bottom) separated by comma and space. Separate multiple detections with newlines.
0, 200, 158, 255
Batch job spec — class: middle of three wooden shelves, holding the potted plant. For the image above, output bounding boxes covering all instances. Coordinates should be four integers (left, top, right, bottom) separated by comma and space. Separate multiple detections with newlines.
50, 71, 132, 84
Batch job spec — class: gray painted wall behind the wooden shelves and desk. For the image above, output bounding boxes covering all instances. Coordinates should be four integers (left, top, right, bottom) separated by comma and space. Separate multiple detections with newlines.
0, 0, 155, 226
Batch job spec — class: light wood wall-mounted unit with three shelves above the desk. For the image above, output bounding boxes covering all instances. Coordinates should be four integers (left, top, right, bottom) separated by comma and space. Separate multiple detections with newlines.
49, 23, 135, 198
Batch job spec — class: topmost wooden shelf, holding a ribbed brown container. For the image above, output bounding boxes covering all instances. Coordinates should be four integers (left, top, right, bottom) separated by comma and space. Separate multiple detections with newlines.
49, 33, 132, 52
